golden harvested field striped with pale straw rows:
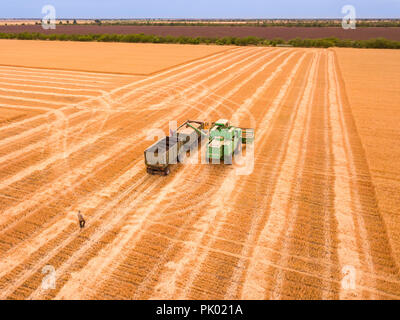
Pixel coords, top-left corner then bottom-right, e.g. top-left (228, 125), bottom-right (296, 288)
top-left (0, 42), bottom-right (400, 299)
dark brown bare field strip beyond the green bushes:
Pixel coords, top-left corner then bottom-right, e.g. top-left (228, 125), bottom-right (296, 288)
top-left (0, 25), bottom-right (400, 41)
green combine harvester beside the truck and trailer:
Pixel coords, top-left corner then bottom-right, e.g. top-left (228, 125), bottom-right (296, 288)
top-left (206, 119), bottom-right (254, 164)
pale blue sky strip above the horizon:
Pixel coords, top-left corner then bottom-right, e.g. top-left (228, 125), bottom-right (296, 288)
top-left (0, 0), bottom-right (400, 18)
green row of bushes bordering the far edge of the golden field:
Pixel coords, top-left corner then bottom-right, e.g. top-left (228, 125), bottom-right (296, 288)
top-left (0, 32), bottom-right (400, 49)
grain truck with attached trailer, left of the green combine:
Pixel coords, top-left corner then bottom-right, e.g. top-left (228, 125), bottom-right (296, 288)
top-left (144, 120), bottom-right (207, 176)
